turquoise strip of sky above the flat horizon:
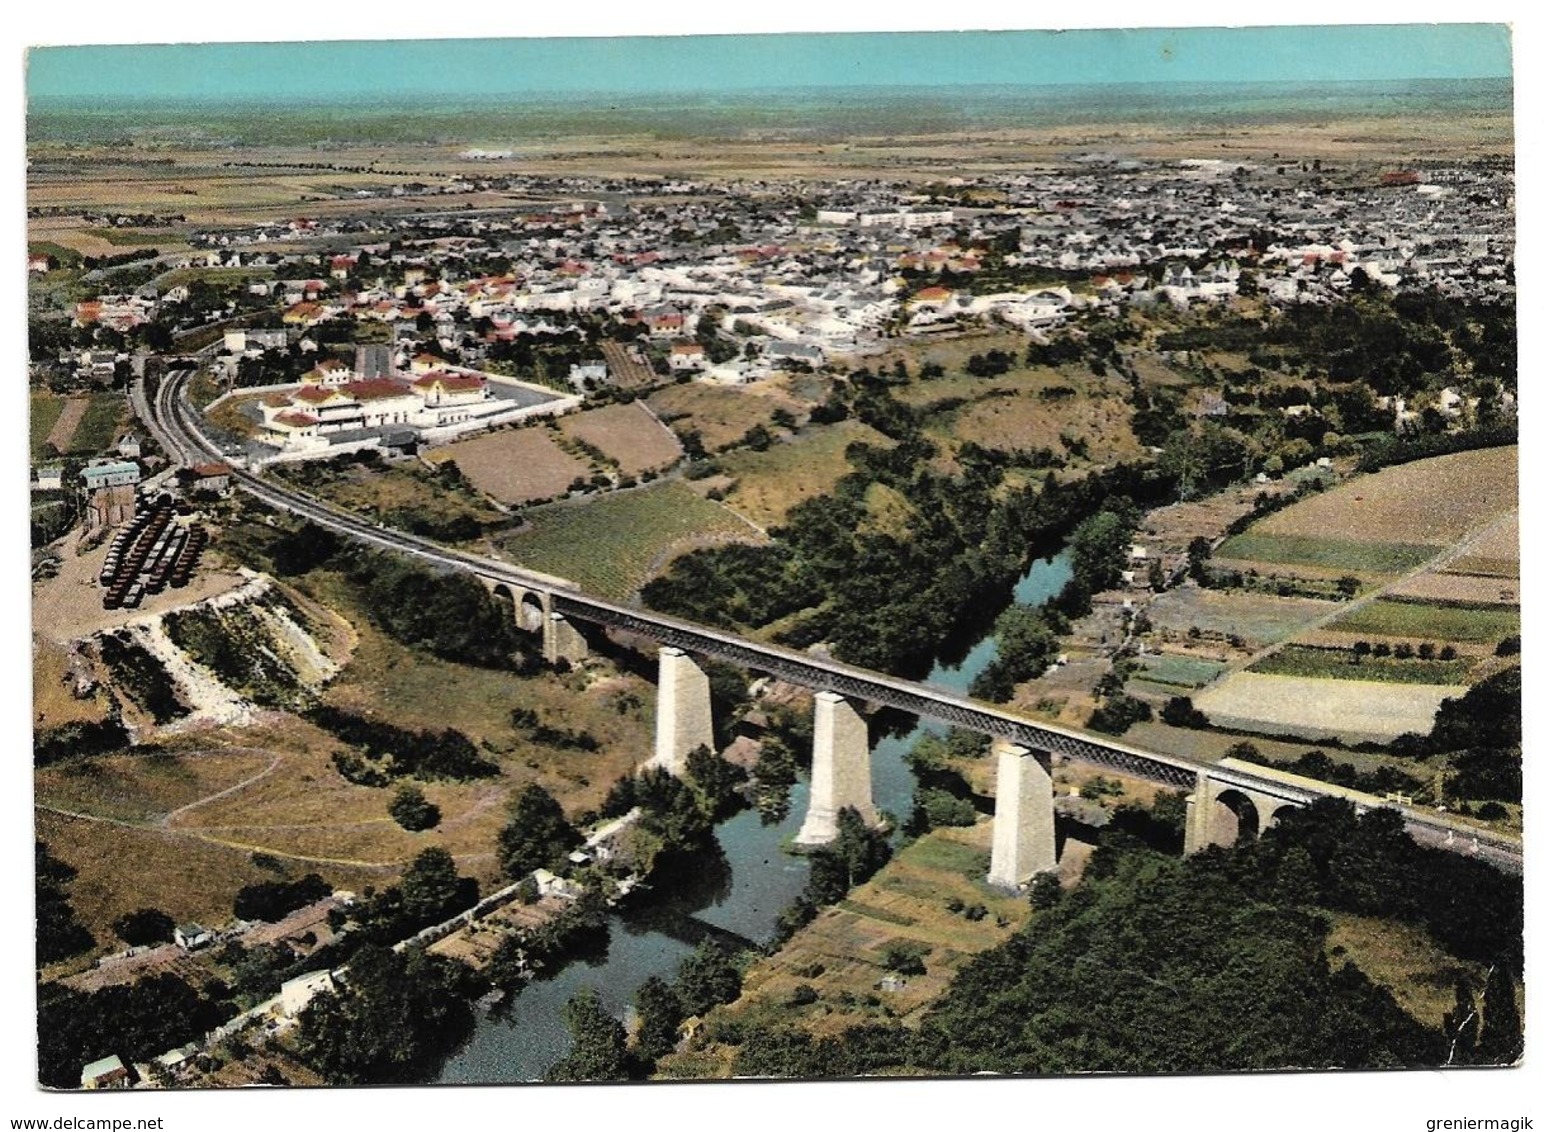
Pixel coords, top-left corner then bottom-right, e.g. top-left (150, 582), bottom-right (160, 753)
top-left (28, 23), bottom-right (1512, 100)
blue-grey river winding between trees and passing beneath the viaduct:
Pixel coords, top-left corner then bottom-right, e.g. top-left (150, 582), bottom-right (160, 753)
top-left (437, 551), bottom-right (1072, 1084)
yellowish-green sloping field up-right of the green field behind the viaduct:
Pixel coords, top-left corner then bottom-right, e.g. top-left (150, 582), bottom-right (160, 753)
top-left (720, 420), bottom-right (896, 527)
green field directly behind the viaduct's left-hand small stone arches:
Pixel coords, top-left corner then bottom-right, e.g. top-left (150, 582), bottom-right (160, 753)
top-left (500, 483), bottom-right (757, 599)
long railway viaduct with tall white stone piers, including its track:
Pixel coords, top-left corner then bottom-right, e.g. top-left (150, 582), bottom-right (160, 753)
top-left (150, 370), bottom-right (1521, 890)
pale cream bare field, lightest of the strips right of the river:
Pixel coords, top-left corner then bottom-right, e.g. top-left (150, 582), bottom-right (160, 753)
top-left (1195, 672), bottom-right (1464, 743)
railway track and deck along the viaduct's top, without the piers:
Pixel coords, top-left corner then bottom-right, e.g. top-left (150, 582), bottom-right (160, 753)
top-left (136, 366), bottom-right (1521, 866)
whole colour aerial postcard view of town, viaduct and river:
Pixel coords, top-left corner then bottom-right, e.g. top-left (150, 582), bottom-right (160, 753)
top-left (17, 25), bottom-right (1524, 1115)
